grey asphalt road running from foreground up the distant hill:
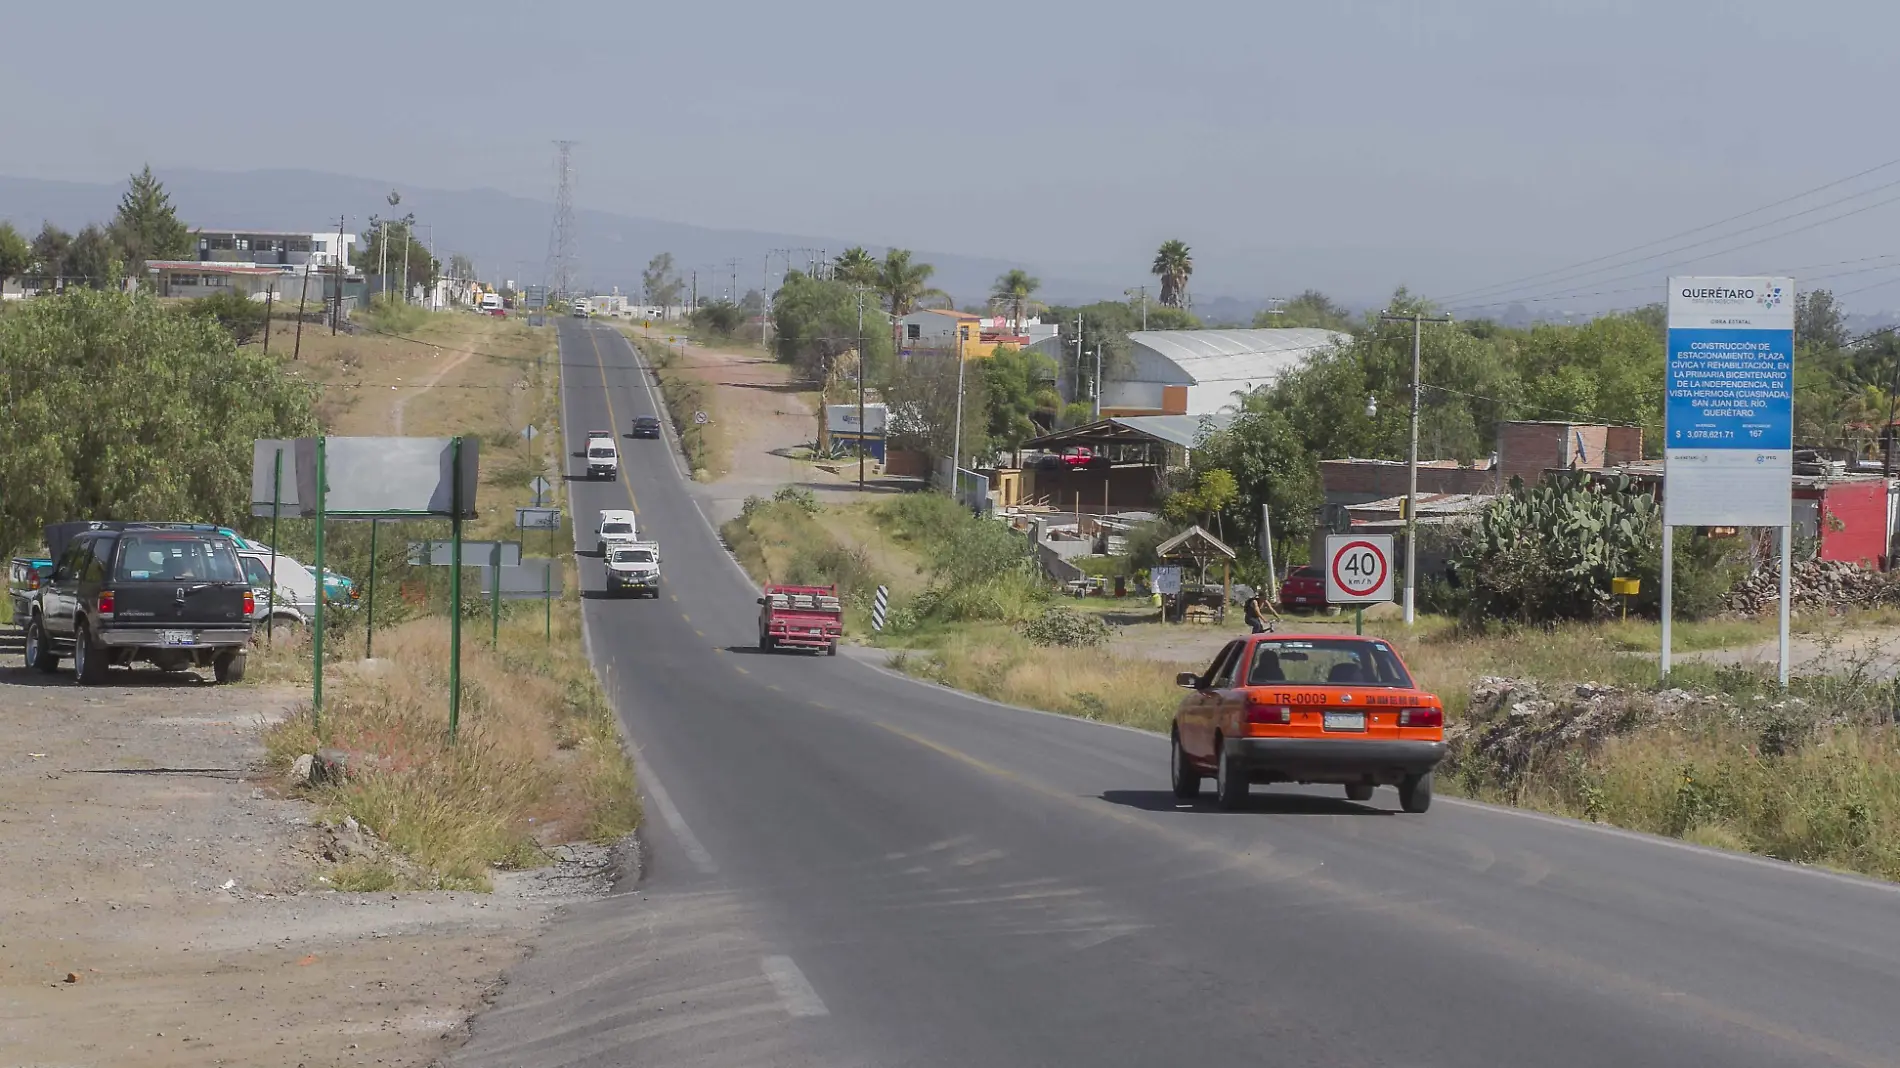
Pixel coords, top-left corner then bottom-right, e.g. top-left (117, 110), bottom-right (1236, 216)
top-left (454, 321), bottom-right (1900, 1068)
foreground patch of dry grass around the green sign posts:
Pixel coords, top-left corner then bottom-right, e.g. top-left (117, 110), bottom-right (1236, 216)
top-left (268, 599), bottom-right (640, 887)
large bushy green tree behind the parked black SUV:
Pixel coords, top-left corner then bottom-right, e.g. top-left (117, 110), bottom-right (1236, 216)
top-left (0, 289), bottom-right (315, 555)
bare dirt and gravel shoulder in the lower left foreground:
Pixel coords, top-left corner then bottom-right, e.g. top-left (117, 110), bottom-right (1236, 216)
top-left (0, 642), bottom-right (604, 1068)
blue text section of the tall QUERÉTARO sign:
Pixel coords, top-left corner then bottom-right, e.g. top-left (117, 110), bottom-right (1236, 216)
top-left (1666, 329), bottom-right (1794, 450)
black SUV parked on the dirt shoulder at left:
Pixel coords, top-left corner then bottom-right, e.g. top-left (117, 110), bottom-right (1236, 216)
top-left (27, 523), bottom-right (257, 686)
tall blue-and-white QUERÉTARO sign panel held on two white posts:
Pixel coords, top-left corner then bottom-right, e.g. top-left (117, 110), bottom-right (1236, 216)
top-left (1663, 277), bottom-right (1794, 526)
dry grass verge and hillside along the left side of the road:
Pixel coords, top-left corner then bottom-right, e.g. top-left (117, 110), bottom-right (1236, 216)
top-left (251, 305), bottom-right (640, 889)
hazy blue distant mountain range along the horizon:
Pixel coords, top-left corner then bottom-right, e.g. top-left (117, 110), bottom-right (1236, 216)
top-left (0, 169), bottom-right (1124, 305)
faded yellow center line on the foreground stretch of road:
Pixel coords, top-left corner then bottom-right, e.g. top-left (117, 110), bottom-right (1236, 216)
top-left (870, 714), bottom-right (1894, 1068)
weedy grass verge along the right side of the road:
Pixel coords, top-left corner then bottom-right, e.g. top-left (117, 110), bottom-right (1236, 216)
top-left (722, 488), bottom-right (1900, 878)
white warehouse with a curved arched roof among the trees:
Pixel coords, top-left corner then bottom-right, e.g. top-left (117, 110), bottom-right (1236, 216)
top-left (1102, 329), bottom-right (1351, 418)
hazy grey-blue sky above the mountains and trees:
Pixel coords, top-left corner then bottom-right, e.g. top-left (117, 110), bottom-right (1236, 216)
top-left (0, 0), bottom-right (1900, 308)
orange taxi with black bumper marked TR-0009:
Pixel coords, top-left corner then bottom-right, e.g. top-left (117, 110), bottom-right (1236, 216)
top-left (1172, 635), bottom-right (1444, 811)
